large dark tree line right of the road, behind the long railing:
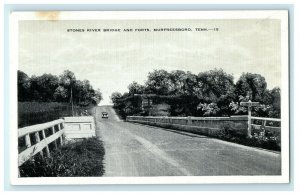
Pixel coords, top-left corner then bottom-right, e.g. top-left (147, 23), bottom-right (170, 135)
top-left (111, 69), bottom-right (280, 118)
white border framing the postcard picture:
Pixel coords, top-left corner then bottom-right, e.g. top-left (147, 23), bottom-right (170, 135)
top-left (9, 10), bottom-right (289, 185)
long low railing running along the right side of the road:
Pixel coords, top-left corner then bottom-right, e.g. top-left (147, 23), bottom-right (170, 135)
top-left (126, 115), bottom-right (281, 137)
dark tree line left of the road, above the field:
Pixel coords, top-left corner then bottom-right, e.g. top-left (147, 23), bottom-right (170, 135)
top-left (17, 70), bottom-right (102, 106)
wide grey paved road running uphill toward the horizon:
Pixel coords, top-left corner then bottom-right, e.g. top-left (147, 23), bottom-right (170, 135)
top-left (95, 106), bottom-right (281, 176)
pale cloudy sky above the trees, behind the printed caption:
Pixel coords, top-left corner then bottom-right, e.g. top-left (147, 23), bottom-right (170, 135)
top-left (18, 19), bottom-right (281, 105)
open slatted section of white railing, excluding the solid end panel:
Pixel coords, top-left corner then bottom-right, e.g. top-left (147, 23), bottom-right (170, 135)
top-left (18, 119), bottom-right (65, 166)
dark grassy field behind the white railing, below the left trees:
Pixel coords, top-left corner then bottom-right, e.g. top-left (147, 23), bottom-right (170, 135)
top-left (18, 102), bottom-right (91, 128)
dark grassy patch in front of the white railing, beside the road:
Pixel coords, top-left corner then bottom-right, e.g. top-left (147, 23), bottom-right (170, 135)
top-left (19, 137), bottom-right (105, 177)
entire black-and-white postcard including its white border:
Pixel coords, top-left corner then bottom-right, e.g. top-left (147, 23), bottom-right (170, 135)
top-left (10, 10), bottom-right (289, 185)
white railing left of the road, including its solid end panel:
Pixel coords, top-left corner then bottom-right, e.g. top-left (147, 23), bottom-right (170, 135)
top-left (18, 116), bottom-right (96, 167)
